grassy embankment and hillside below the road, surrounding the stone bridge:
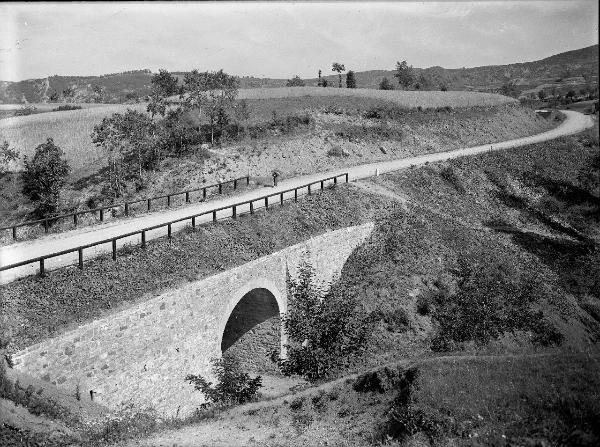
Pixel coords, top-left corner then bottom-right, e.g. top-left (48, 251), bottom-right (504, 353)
top-left (0, 124), bottom-right (600, 446)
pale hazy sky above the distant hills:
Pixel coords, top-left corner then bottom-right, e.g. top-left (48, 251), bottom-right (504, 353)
top-left (0, 0), bottom-right (598, 81)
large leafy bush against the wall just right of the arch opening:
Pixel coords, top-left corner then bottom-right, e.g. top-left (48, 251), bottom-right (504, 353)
top-left (279, 259), bottom-right (372, 382)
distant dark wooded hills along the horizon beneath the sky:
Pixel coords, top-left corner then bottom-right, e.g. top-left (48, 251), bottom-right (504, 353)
top-left (0, 45), bottom-right (598, 103)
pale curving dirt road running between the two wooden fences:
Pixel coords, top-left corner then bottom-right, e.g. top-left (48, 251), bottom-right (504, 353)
top-left (0, 111), bottom-right (594, 284)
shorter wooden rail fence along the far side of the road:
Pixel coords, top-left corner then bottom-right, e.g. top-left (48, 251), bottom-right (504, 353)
top-left (0, 175), bottom-right (250, 240)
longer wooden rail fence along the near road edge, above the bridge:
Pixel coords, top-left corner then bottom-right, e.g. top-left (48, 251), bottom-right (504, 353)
top-left (0, 173), bottom-right (349, 276)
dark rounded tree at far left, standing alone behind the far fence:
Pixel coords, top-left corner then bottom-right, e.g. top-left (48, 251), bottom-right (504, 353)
top-left (21, 138), bottom-right (70, 218)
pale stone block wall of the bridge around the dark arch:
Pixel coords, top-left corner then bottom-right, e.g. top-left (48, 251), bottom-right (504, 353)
top-left (14, 223), bottom-right (373, 415)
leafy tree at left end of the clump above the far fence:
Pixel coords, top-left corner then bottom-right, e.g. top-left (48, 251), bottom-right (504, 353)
top-left (91, 109), bottom-right (161, 198)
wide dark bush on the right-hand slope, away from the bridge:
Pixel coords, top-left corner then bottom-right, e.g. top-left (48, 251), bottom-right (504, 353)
top-left (432, 253), bottom-right (562, 351)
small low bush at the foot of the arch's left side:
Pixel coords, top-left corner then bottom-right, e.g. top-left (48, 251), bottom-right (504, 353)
top-left (185, 355), bottom-right (262, 405)
